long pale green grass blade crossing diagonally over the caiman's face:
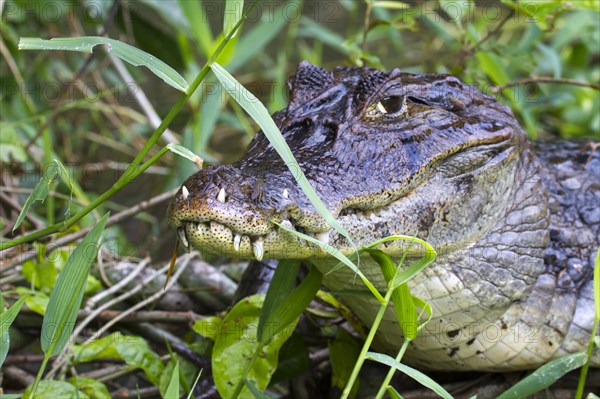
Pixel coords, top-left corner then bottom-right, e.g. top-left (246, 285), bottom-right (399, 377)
top-left (212, 63), bottom-right (354, 250)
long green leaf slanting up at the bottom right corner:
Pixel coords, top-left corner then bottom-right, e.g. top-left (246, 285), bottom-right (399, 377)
top-left (498, 352), bottom-right (587, 399)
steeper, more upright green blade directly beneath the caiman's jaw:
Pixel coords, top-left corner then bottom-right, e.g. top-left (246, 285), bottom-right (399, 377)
top-left (256, 260), bottom-right (300, 342)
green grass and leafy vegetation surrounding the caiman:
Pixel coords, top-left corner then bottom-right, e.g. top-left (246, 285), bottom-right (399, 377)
top-left (0, 0), bottom-right (600, 398)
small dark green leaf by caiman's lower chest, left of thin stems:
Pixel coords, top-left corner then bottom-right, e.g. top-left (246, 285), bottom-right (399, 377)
top-left (327, 327), bottom-right (360, 397)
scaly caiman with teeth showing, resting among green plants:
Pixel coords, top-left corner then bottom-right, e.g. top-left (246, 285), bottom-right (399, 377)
top-left (168, 62), bottom-right (600, 371)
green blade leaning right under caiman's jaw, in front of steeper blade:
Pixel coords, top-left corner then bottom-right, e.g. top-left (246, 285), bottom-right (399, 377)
top-left (259, 267), bottom-right (323, 344)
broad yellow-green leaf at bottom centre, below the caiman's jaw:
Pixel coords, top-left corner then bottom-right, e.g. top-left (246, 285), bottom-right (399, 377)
top-left (212, 295), bottom-right (295, 398)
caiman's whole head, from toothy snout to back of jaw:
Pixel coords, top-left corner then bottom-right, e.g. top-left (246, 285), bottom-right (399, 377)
top-left (168, 62), bottom-right (527, 259)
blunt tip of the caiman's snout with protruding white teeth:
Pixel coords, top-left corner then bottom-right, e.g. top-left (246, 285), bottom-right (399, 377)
top-left (168, 165), bottom-right (322, 260)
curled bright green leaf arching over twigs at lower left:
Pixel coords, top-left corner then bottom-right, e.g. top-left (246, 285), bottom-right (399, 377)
top-left (72, 333), bottom-right (164, 384)
